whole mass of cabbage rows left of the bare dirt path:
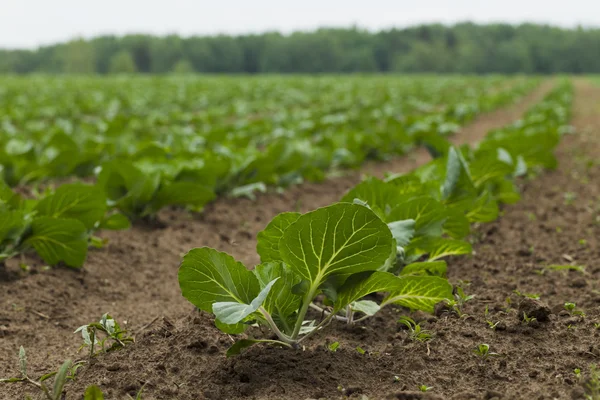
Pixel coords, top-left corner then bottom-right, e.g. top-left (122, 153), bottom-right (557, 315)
top-left (0, 77), bottom-right (539, 267)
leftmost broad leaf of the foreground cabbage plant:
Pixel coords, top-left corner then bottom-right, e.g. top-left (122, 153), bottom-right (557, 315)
top-left (178, 247), bottom-right (260, 312)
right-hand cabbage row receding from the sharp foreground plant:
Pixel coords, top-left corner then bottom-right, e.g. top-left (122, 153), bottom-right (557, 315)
top-left (179, 82), bottom-right (572, 355)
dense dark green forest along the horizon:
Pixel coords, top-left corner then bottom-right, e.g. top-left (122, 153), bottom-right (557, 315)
top-left (0, 23), bottom-right (600, 74)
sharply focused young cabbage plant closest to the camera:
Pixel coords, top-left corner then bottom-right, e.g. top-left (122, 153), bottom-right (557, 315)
top-left (179, 203), bottom-right (451, 355)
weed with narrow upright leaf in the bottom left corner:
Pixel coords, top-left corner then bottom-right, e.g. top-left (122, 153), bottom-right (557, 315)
top-left (0, 346), bottom-right (82, 400)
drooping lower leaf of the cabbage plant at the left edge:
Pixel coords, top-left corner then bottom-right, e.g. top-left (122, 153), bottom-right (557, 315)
top-left (25, 217), bottom-right (88, 267)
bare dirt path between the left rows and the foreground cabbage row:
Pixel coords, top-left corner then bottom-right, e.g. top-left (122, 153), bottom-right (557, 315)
top-left (0, 81), bottom-right (552, 399)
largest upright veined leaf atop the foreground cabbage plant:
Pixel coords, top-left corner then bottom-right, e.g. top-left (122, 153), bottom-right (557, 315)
top-left (279, 203), bottom-right (393, 288)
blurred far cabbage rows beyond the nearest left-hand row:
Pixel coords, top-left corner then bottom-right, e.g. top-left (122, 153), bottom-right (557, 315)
top-left (0, 76), bottom-right (528, 187)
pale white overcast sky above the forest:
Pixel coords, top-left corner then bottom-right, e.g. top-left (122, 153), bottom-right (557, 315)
top-left (0, 0), bottom-right (600, 48)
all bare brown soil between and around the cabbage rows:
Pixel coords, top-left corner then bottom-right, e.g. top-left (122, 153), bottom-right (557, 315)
top-left (0, 83), bottom-right (600, 400)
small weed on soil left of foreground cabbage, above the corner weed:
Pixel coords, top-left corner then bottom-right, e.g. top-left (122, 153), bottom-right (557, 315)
top-left (75, 314), bottom-right (134, 357)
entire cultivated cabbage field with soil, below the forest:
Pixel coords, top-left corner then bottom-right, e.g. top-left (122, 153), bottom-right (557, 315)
top-left (0, 76), bottom-right (600, 400)
